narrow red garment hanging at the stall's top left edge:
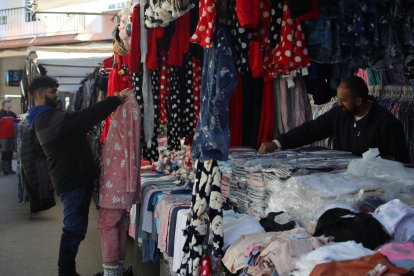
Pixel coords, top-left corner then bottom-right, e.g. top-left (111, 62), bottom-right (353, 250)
top-left (127, 4), bottom-right (141, 73)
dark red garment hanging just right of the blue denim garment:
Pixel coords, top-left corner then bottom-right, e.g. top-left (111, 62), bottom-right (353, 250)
top-left (229, 73), bottom-right (243, 147)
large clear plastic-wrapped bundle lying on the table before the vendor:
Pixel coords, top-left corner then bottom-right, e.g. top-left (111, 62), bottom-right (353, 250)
top-left (266, 173), bottom-right (384, 232)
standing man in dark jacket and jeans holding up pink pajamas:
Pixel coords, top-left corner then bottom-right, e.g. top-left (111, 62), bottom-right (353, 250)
top-left (27, 76), bottom-right (129, 276)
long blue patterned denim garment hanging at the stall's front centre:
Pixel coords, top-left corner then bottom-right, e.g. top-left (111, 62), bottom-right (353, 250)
top-left (192, 26), bottom-right (237, 161)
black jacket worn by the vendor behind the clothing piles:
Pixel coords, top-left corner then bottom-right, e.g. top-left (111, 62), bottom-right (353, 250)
top-left (277, 101), bottom-right (410, 163)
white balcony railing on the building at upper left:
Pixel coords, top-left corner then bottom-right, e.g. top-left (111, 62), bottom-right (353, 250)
top-left (0, 7), bottom-right (86, 40)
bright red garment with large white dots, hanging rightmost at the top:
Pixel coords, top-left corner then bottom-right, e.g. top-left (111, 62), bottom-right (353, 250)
top-left (264, 0), bottom-right (310, 78)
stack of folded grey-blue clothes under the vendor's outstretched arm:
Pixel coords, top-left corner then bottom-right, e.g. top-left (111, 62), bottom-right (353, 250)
top-left (229, 147), bottom-right (355, 217)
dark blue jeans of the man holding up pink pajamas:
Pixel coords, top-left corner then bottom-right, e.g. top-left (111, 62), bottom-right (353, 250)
top-left (58, 185), bottom-right (92, 276)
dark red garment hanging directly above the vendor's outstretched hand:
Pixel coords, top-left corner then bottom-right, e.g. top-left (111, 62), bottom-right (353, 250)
top-left (257, 80), bottom-right (275, 146)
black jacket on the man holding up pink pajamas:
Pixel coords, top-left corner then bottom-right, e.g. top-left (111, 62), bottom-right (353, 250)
top-left (35, 97), bottom-right (121, 194)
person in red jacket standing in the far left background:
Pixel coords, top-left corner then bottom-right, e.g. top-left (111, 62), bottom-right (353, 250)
top-left (0, 100), bottom-right (17, 175)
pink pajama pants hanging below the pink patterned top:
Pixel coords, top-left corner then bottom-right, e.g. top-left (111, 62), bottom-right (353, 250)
top-left (97, 207), bottom-right (128, 263)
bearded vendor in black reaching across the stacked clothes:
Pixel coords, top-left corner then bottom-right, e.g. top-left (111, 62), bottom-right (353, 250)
top-left (259, 76), bottom-right (410, 163)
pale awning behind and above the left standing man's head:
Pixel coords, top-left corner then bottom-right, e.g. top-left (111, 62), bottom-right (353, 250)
top-left (27, 42), bottom-right (113, 93)
